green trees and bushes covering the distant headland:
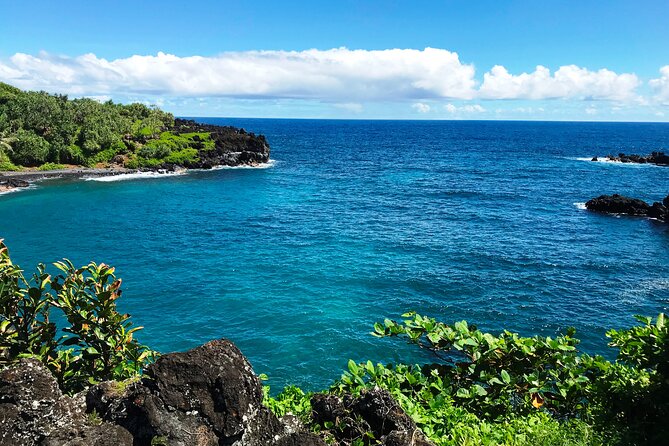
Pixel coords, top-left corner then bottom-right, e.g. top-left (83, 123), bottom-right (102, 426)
top-left (0, 82), bottom-right (214, 170)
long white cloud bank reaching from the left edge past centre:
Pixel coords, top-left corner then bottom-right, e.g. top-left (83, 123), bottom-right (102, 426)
top-left (0, 48), bottom-right (476, 103)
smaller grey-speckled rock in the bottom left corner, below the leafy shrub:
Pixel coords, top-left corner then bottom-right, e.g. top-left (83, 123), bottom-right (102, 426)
top-left (0, 359), bottom-right (133, 446)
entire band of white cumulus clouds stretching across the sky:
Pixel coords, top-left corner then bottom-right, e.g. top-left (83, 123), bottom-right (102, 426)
top-left (0, 48), bottom-right (648, 106)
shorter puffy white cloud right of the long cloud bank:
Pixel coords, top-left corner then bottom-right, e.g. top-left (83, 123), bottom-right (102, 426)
top-left (479, 65), bottom-right (639, 100)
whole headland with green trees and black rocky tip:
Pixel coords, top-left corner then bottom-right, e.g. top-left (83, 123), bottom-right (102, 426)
top-left (0, 82), bottom-right (269, 171)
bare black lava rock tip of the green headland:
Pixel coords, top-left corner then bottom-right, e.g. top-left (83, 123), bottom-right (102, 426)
top-left (171, 119), bottom-right (270, 169)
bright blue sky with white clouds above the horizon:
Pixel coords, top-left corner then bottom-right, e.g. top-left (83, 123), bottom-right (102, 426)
top-left (0, 0), bottom-right (669, 122)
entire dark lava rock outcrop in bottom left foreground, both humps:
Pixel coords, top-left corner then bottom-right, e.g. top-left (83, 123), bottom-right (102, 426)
top-left (0, 340), bottom-right (325, 446)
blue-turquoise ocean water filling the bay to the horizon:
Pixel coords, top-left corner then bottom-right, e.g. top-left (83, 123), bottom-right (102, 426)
top-left (0, 119), bottom-right (669, 389)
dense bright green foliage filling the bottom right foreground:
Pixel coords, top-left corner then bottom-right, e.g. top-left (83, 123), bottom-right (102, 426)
top-left (266, 313), bottom-right (669, 445)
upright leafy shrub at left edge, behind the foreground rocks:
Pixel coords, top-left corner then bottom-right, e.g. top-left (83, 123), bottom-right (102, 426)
top-left (0, 240), bottom-right (155, 392)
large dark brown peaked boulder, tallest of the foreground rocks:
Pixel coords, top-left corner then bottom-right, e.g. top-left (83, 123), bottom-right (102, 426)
top-left (86, 340), bottom-right (324, 446)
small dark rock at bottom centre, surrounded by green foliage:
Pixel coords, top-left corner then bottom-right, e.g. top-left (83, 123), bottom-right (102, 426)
top-left (311, 389), bottom-right (432, 446)
